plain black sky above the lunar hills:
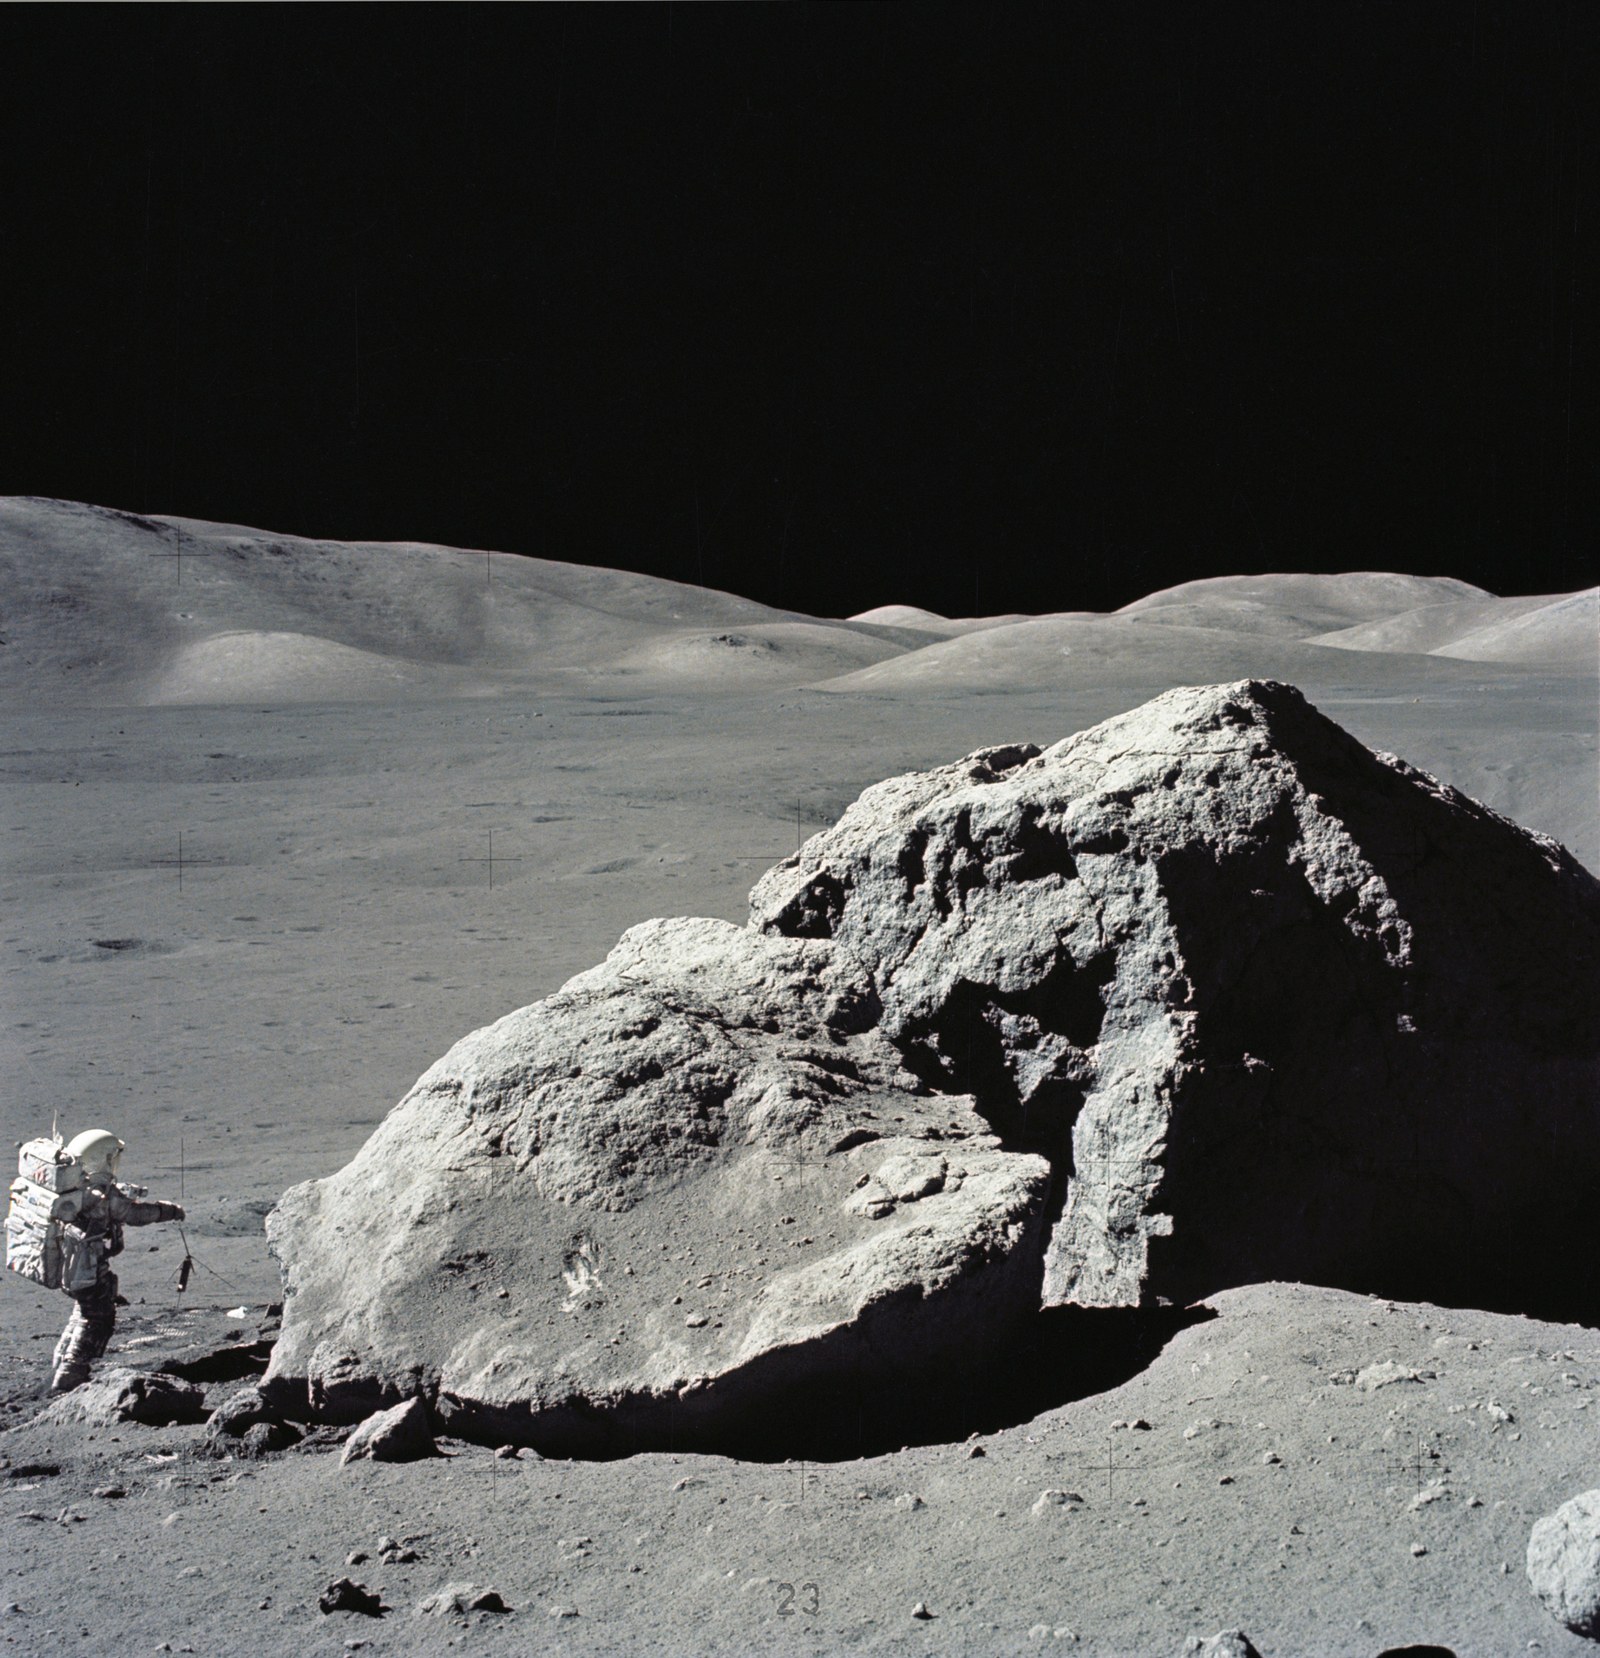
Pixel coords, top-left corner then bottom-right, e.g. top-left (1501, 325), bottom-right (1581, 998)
top-left (0, 0), bottom-right (1600, 615)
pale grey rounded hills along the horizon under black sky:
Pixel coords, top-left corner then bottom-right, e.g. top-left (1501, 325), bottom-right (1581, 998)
top-left (0, 496), bottom-right (1600, 706)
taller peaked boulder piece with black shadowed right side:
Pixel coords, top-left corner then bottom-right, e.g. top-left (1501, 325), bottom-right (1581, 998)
top-left (751, 681), bottom-right (1600, 1321)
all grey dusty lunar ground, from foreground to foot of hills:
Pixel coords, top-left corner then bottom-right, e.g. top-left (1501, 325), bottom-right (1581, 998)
top-left (0, 510), bottom-right (1600, 1658)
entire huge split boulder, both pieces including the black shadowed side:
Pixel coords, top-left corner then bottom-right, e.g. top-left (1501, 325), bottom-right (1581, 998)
top-left (264, 681), bottom-right (1600, 1454)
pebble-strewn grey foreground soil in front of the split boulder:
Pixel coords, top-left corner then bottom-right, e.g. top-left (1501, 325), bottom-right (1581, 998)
top-left (0, 1285), bottom-right (1600, 1658)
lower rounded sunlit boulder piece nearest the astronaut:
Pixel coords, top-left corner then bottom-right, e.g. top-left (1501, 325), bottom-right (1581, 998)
top-left (264, 920), bottom-right (1051, 1454)
